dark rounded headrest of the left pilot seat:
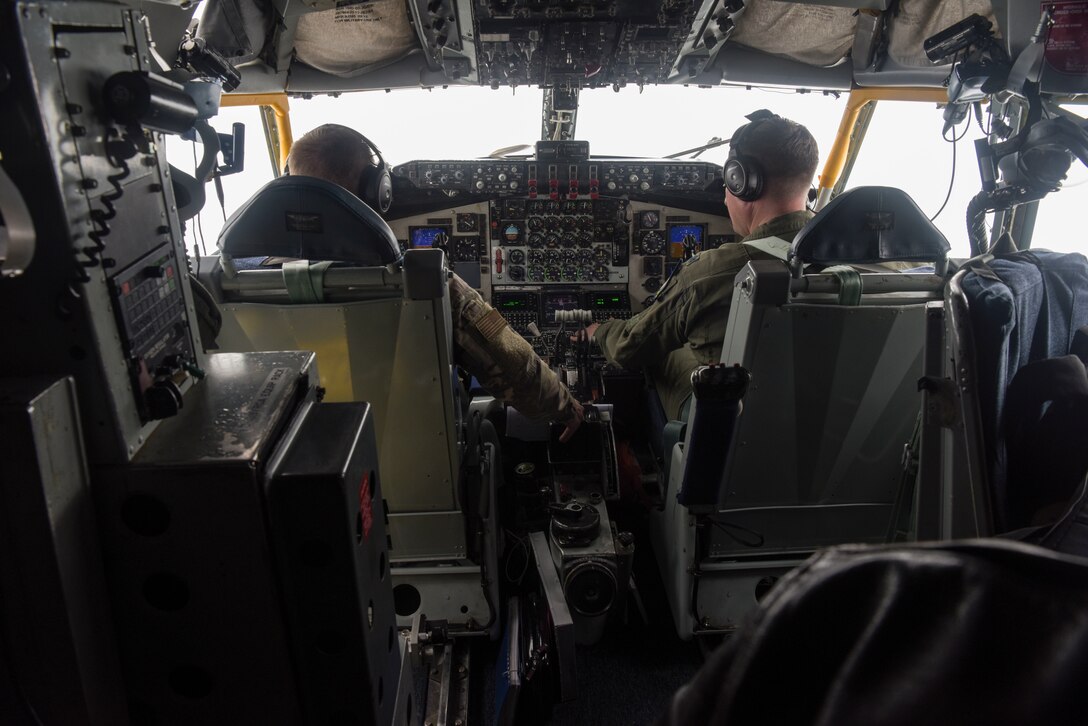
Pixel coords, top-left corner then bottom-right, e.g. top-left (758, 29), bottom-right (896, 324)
top-left (219, 175), bottom-right (400, 267)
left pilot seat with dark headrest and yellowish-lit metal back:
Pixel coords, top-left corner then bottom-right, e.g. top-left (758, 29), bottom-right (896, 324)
top-left (199, 175), bottom-right (498, 632)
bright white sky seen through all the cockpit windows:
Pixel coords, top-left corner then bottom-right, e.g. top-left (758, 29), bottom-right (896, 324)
top-left (168, 86), bottom-right (1088, 261)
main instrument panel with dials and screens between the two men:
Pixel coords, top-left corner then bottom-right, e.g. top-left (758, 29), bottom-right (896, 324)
top-left (390, 158), bottom-right (737, 346)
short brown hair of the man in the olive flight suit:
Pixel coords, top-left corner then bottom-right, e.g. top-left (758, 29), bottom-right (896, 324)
top-left (733, 116), bottom-right (819, 196)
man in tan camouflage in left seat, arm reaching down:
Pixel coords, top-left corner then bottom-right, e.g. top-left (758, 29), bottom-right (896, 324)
top-left (287, 124), bottom-right (583, 441)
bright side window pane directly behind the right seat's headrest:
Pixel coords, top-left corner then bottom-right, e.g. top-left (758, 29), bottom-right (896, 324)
top-left (846, 101), bottom-right (987, 257)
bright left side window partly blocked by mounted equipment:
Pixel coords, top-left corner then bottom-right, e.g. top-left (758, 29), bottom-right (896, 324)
top-left (166, 106), bottom-right (274, 255)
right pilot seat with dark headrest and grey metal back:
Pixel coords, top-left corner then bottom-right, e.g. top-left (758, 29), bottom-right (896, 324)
top-left (652, 187), bottom-right (949, 638)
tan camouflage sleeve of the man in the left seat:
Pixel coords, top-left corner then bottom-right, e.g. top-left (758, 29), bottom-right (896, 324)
top-left (449, 275), bottom-right (576, 423)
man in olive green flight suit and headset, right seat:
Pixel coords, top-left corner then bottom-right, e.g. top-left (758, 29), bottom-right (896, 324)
top-left (586, 111), bottom-right (819, 419)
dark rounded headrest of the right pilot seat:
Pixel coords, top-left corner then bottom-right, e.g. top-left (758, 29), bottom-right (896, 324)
top-left (790, 186), bottom-right (949, 264)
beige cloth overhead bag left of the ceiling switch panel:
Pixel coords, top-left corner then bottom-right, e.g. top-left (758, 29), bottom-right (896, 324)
top-left (295, 0), bottom-right (420, 77)
